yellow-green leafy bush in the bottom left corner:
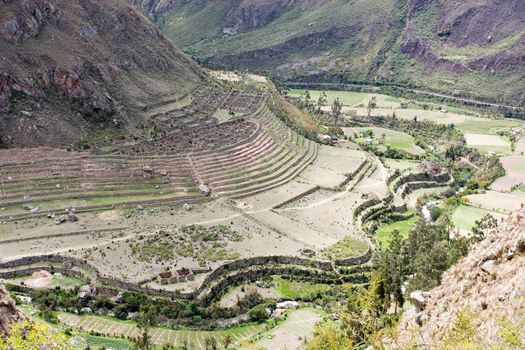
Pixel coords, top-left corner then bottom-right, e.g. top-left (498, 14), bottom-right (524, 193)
top-left (0, 320), bottom-right (73, 350)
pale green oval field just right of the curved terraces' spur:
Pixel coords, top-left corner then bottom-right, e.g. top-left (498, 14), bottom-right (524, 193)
top-left (352, 127), bottom-right (424, 155)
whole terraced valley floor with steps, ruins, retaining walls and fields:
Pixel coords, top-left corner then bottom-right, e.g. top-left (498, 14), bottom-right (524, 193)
top-left (5, 72), bottom-right (525, 349)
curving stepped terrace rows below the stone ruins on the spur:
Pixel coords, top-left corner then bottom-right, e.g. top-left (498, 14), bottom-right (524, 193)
top-left (0, 96), bottom-right (318, 217)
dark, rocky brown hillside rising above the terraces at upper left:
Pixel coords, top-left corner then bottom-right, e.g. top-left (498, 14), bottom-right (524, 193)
top-left (0, 0), bottom-right (206, 147)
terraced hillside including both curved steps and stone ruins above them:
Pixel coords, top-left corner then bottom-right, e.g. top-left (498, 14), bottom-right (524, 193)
top-left (0, 90), bottom-right (318, 220)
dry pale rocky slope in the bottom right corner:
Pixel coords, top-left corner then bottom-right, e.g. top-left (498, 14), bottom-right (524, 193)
top-left (396, 207), bottom-right (525, 349)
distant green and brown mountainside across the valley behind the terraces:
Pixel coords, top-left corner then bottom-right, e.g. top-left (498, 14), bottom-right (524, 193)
top-left (129, 0), bottom-right (525, 105)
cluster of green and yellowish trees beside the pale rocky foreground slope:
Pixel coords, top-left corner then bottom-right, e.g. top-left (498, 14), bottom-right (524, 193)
top-left (308, 215), bottom-right (476, 350)
